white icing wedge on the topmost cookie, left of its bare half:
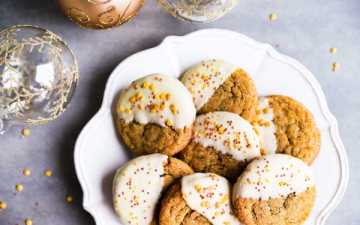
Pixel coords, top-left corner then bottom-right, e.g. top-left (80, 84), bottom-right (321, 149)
top-left (181, 59), bottom-right (236, 110)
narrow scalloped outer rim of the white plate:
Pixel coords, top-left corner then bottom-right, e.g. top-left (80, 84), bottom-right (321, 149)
top-left (74, 28), bottom-right (349, 225)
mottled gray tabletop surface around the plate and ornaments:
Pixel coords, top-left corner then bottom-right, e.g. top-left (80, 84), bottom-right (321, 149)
top-left (0, 0), bottom-right (360, 225)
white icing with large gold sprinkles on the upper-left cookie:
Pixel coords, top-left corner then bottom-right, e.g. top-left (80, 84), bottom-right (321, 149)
top-left (117, 74), bottom-right (196, 129)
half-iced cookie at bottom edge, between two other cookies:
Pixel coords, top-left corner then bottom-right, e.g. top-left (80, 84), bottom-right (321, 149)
top-left (159, 173), bottom-right (240, 225)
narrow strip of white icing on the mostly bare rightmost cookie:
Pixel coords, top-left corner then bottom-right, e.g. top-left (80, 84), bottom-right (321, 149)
top-left (256, 97), bottom-right (277, 154)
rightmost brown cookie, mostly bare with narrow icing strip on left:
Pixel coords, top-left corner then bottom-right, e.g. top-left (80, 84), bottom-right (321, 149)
top-left (255, 95), bottom-right (320, 165)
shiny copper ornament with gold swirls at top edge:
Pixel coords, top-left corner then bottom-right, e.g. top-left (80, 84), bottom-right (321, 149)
top-left (58, 0), bottom-right (144, 29)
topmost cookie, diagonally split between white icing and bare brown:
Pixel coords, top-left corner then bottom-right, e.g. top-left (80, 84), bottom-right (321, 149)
top-left (181, 60), bottom-right (257, 121)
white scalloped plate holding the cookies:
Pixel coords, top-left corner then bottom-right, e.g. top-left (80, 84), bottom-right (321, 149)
top-left (75, 29), bottom-right (349, 225)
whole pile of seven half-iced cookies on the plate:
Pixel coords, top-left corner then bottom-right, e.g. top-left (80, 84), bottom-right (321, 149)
top-left (113, 60), bottom-right (320, 225)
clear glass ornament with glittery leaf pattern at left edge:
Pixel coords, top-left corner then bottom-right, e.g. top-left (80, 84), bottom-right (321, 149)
top-left (0, 25), bottom-right (79, 133)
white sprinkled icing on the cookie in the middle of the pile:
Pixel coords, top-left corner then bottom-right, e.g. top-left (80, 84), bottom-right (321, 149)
top-left (193, 112), bottom-right (261, 161)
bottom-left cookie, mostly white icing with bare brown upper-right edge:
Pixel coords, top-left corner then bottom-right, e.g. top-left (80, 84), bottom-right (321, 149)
top-left (113, 153), bottom-right (193, 225)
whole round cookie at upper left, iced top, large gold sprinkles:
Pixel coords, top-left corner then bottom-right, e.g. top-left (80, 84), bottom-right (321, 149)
top-left (115, 74), bottom-right (196, 156)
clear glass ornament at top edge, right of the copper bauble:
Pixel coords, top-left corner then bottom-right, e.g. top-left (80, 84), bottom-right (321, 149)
top-left (158, 0), bottom-right (238, 23)
